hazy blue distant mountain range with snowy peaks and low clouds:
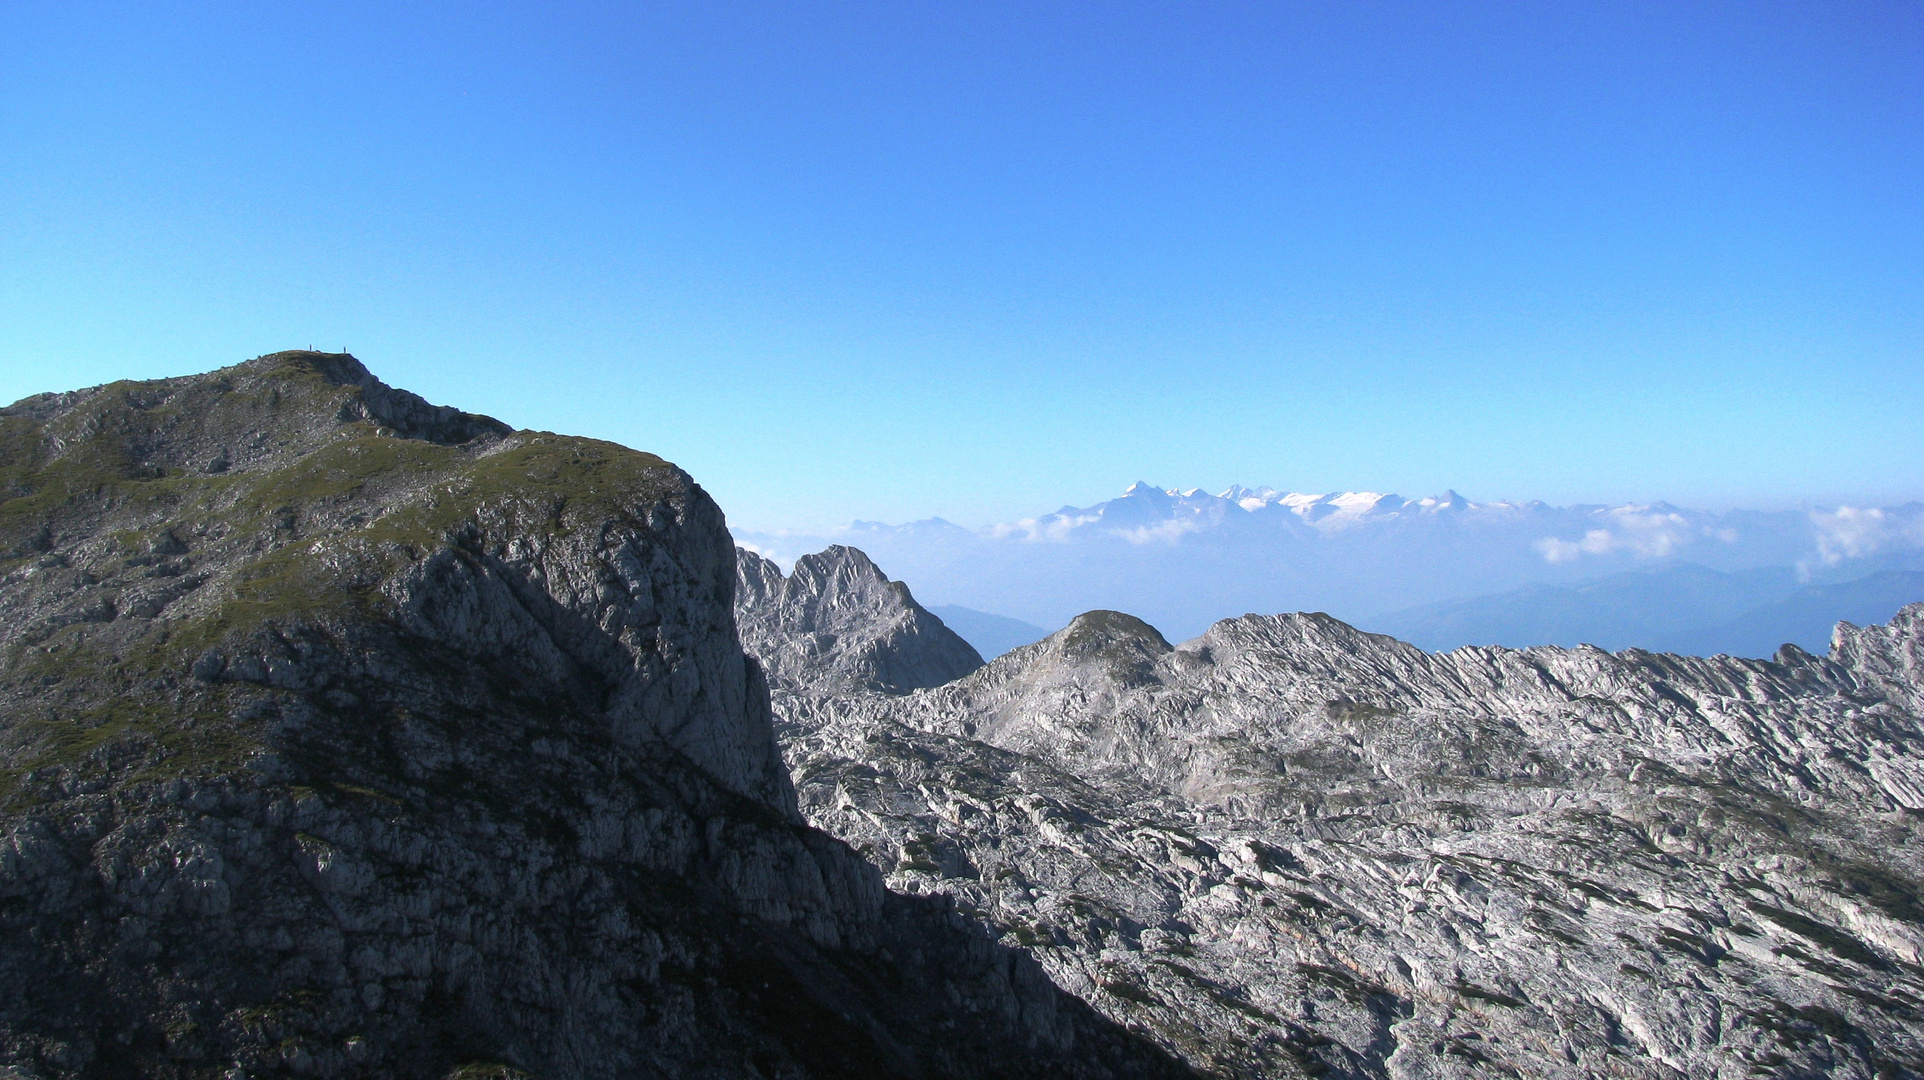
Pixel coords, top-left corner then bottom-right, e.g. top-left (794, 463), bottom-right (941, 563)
top-left (735, 483), bottom-right (1924, 656)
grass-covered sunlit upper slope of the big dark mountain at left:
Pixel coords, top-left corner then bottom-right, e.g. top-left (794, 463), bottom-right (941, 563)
top-left (0, 365), bottom-right (687, 801)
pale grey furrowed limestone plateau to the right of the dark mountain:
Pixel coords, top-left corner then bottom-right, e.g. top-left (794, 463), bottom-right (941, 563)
top-left (737, 549), bottom-right (1924, 1080)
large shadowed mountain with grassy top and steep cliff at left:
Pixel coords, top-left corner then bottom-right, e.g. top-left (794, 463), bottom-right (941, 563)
top-left (0, 352), bottom-right (1179, 1080)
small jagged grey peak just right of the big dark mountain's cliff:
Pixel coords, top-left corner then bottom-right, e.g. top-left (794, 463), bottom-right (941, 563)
top-left (735, 547), bottom-right (981, 693)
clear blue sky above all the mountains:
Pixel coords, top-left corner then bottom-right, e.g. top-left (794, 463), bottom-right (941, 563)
top-left (0, 0), bottom-right (1924, 527)
